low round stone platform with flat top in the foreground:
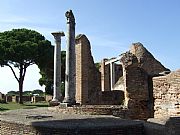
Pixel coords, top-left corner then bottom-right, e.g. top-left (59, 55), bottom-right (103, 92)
top-left (0, 106), bottom-right (144, 135)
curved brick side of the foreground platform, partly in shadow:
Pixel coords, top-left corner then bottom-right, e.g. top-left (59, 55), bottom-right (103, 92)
top-left (0, 121), bottom-right (144, 135)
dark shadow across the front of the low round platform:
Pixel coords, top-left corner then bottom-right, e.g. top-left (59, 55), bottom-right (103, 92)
top-left (32, 118), bottom-right (144, 135)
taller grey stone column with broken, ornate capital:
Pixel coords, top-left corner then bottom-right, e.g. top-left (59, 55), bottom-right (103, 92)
top-left (64, 10), bottom-right (76, 105)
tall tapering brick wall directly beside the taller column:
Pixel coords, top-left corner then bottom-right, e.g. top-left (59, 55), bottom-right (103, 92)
top-left (76, 35), bottom-right (101, 104)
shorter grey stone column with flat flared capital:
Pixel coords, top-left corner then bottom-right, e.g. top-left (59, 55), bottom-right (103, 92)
top-left (51, 32), bottom-right (64, 102)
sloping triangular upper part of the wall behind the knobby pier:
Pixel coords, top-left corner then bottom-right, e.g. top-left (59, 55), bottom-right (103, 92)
top-left (130, 43), bottom-right (169, 76)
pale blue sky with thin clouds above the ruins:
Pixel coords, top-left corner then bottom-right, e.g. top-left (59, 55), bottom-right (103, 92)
top-left (0, 0), bottom-right (180, 92)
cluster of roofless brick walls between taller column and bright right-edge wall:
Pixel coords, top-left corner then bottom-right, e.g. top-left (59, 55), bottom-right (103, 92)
top-left (73, 35), bottom-right (174, 119)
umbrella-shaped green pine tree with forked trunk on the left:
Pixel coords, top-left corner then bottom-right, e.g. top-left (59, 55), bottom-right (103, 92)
top-left (0, 28), bottom-right (53, 104)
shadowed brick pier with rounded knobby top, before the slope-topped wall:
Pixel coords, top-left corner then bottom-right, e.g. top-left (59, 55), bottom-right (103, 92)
top-left (121, 52), bottom-right (149, 119)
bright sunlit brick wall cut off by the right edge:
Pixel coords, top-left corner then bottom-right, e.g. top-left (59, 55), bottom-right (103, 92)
top-left (153, 70), bottom-right (180, 118)
